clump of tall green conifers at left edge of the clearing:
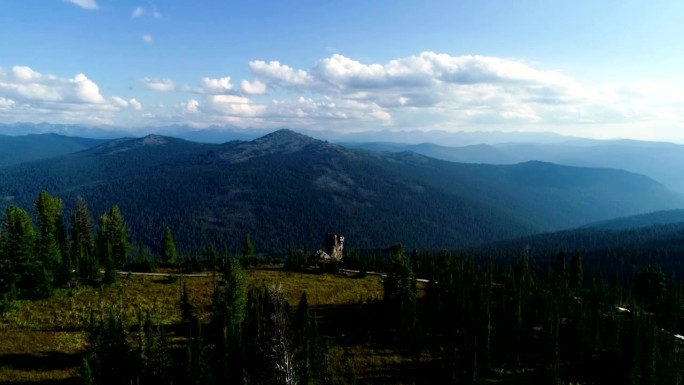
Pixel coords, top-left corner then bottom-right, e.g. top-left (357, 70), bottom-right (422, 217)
top-left (0, 191), bottom-right (139, 301)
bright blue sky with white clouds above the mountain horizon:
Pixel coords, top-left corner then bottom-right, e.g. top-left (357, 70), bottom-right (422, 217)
top-left (0, 0), bottom-right (684, 143)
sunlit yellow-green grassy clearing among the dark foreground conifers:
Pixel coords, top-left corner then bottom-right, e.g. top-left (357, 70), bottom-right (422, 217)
top-left (0, 269), bottom-right (382, 384)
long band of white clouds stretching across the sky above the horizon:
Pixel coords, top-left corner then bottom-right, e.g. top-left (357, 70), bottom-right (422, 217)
top-left (0, 52), bottom-right (684, 140)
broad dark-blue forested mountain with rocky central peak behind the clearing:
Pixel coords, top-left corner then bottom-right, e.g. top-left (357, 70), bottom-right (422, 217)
top-left (0, 130), bottom-right (684, 252)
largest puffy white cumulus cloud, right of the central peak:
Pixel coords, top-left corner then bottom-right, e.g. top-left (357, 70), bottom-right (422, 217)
top-left (250, 52), bottom-right (616, 125)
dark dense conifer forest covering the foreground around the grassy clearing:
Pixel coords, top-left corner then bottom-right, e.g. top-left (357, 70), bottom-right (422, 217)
top-left (0, 191), bottom-right (684, 384)
